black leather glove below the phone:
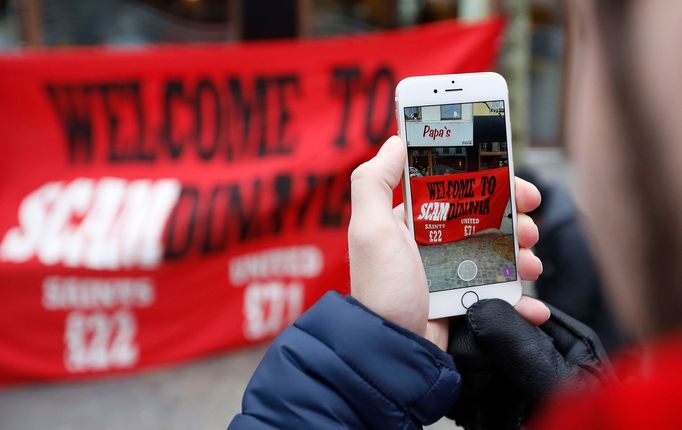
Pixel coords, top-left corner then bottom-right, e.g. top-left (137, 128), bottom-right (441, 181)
top-left (448, 299), bottom-right (612, 429)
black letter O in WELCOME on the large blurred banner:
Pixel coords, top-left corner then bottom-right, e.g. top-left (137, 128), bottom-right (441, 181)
top-left (194, 79), bottom-right (222, 160)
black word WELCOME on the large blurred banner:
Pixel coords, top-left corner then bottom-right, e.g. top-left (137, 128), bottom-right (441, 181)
top-left (44, 73), bottom-right (302, 163)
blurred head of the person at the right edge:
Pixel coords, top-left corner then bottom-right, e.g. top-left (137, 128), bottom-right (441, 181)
top-left (565, 0), bottom-right (682, 336)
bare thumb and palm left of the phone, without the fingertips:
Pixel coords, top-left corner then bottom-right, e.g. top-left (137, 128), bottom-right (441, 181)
top-left (348, 136), bottom-right (429, 336)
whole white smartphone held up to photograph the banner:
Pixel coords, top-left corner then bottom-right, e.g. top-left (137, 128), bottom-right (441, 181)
top-left (396, 73), bottom-right (521, 318)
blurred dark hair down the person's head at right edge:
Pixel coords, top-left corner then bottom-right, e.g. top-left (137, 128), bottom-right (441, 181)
top-left (595, 0), bottom-right (682, 334)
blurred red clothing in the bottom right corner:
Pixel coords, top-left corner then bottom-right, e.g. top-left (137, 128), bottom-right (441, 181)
top-left (532, 336), bottom-right (682, 430)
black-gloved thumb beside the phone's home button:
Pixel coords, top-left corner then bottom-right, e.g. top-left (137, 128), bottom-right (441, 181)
top-left (467, 299), bottom-right (577, 400)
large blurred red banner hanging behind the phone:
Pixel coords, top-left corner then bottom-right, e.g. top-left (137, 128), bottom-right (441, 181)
top-left (0, 20), bottom-right (503, 383)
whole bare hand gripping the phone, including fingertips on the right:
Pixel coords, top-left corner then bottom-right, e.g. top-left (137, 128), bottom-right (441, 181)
top-left (348, 136), bottom-right (549, 340)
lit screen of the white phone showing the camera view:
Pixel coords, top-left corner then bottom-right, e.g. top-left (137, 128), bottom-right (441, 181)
top-left (404, 100), bottom-right (517, 292)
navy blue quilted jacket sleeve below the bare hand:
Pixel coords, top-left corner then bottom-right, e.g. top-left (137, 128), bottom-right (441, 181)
top-left (229, 292), bottom-right (461, 430)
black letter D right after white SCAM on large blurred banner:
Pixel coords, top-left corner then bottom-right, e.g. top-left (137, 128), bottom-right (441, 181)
top-left (164, 187), bottom-right (199, 260)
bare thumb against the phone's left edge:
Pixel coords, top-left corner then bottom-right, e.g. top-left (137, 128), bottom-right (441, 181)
top-left (350, 136), bottom-right (407, 223)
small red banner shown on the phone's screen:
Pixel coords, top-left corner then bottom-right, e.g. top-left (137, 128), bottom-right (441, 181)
top-left (410, 167), bottom-right (510, 245)
